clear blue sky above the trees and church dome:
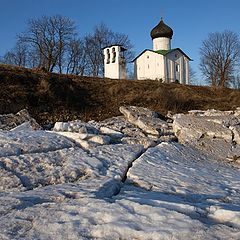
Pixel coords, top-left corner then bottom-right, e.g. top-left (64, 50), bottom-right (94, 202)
top-left (0, 0), bottom-right (240, 82)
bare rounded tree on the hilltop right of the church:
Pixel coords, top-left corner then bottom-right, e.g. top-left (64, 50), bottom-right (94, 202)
top-left (200, 30), bottom-right (240, 87)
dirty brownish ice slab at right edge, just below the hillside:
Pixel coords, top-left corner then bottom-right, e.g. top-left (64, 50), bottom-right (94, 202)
top-left (173, 110), bottom-right (240, 164)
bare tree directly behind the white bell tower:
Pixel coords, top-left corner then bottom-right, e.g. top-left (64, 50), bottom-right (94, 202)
top-left (85, 24), bottom-right (133, 76)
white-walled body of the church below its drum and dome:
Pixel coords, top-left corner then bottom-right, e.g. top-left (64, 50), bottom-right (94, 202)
top-left (134, 49), bottom-right (189, 84)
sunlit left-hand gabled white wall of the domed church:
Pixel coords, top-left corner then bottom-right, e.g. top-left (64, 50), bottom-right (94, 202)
top-left (135, 51), bottom-right (165, 80)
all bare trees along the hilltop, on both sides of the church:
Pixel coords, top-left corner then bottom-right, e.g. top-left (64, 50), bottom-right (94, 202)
top-left (0, 15), bottom-right (240, 89)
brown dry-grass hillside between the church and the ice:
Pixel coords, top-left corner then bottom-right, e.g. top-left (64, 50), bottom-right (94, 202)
top-left (0, 65), bottom-right (240, 124)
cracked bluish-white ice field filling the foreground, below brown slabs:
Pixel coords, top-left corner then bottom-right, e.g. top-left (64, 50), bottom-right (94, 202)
top-left (0, 109), bottom-right (240, 240)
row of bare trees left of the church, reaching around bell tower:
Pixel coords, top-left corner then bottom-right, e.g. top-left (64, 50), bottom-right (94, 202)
top-left (1, 15), bottom-right (133, 76)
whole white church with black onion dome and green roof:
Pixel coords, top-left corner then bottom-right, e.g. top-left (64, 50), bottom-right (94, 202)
top-left (133, 18), bottom-right (191, 84)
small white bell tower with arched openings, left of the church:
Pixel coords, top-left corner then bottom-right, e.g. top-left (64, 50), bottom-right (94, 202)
top-left (104, 45), bottom-right (126, 79)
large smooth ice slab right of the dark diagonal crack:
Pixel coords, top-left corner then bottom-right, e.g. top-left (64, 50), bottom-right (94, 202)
top-left (128, 143), bottom-right (240, 227)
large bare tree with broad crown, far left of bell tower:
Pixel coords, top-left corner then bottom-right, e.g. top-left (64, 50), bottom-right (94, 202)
top-left (18, 15), bottom-right (75, 73)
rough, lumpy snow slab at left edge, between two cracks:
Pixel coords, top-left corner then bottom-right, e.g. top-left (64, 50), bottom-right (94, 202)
top-left (0, 148), bottom-right (102, 189)
